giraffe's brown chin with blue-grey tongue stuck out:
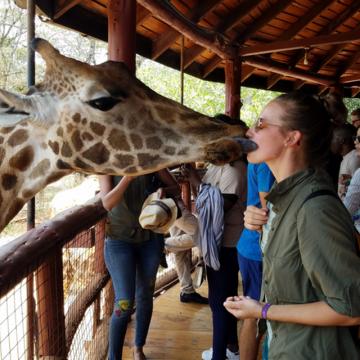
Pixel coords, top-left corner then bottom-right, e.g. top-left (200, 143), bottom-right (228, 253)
top-left (205, 137), bottom-right (257, 165)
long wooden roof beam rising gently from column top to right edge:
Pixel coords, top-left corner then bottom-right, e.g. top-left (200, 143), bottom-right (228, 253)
top-left (239, 29), bottom-right (360, 56)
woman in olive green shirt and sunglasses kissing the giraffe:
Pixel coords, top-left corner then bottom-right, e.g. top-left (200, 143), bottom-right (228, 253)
top-left (224, 92), bottom-right (360, 360)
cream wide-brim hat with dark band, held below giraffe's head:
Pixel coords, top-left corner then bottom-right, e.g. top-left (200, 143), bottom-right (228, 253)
top-left (139, 192), bottom-right (178, 234)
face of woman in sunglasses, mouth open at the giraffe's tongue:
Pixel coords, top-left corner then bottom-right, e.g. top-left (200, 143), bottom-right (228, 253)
top-left (246, 101), bottom-right (286, 164)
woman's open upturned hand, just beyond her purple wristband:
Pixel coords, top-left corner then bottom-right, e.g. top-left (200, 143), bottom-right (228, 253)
top-left (224, 296), bottom-right (262, 319)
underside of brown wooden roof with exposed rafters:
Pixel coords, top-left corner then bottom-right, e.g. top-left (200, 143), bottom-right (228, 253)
top-left (16, 0), bottom-right (360, 97)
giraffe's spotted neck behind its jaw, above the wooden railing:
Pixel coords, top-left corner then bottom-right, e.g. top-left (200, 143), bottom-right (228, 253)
top-left (0, 123), bottom-right (71, 232)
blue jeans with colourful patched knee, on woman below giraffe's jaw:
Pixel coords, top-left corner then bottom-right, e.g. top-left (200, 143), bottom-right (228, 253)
top-left (104, 233), bottom-right (164, 360)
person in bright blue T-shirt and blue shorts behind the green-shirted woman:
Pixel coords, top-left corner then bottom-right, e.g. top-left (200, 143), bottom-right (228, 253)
top-left (237, 163), bottom-right (274, 360)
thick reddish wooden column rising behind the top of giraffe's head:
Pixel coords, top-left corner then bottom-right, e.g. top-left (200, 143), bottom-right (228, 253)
top-left (108, 0), bottom-right (136, 73)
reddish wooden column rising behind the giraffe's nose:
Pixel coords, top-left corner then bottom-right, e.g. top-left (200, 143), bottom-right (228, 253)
top-left (225, 58), bottom-right (241, 118)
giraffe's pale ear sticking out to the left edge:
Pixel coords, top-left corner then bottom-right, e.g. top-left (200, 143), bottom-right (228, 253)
top-left (0, 89), bottom-right (56, 127)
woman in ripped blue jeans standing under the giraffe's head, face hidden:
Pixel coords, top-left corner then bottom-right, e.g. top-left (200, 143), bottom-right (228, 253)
top-left (99, 170), bottom-right (179, 360)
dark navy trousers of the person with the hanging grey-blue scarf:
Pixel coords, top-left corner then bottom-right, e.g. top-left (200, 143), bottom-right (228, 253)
top-left (206, 247), bottom-right (239, 360)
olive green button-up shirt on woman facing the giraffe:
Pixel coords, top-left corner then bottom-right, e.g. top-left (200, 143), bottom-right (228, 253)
top-left (263, 169), bottom-right (360, 360)
